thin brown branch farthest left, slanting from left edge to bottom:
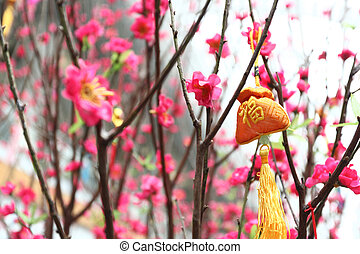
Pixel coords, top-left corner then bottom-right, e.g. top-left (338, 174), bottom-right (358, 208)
top-left (0, 24), bottom-right (68, 238)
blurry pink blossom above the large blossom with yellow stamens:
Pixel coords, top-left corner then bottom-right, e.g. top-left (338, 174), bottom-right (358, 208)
top-left (75, 19), bottom-right (104, 45)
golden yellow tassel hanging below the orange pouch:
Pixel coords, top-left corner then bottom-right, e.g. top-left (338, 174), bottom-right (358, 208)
top-left (256, 145), bottom-right (290, 239)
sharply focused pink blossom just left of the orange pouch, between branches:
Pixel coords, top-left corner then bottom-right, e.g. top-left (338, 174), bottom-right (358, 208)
top-left (186, 71), bottom-right (222, 108)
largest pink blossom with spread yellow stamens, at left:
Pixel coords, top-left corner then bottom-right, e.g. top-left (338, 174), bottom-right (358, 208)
top-left (62, 59), bottom-right (114, 126)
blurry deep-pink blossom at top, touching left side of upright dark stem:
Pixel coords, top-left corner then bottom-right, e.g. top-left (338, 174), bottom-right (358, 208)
top-left (130, 15), bottom-right (155, 42)
